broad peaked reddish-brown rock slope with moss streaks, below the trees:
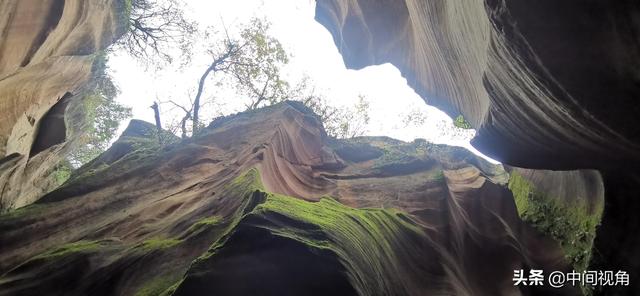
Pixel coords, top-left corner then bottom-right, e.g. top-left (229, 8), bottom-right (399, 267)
top-left (0, 103), bottom-right (579, 295)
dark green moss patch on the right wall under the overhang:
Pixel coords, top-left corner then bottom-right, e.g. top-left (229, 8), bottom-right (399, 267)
top-left (509, 172), bottom-right (602, 294)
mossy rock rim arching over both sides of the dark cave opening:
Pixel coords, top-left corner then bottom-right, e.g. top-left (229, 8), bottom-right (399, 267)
top-left (178, 169), bottom-right (428, 295)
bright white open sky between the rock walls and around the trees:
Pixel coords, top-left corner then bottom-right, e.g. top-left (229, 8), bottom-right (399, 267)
top-left (109, 0), bottom-right (498, 162)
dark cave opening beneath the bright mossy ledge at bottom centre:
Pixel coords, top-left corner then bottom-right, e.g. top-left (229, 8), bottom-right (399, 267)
top-left (174, 225), bottom-right (357, 296)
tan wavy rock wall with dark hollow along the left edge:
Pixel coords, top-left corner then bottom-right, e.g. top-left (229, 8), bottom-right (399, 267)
top-left (0, 0), bottom-right (124, 212)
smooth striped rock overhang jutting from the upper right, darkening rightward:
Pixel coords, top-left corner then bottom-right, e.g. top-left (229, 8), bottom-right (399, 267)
top-left (316, 0), bottom-right (640, 169)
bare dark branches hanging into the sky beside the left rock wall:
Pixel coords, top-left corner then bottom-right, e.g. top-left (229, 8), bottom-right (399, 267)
top-left (117, 0), bottom-right (197, 65)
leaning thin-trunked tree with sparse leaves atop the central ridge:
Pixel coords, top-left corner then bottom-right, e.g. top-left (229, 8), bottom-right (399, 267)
top-left (162, 18), bottom-right (288, 136)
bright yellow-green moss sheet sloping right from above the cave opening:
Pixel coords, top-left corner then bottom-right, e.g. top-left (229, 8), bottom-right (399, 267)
top-left (251, 193), bottom-right (426, 295)
